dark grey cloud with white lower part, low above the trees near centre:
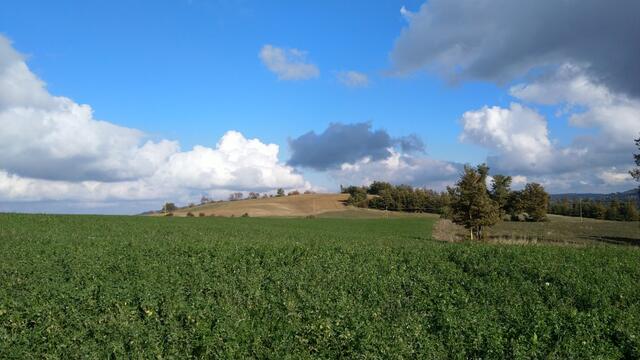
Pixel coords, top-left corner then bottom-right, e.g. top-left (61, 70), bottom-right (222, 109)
top-left (289, 123), bottom-right (462, 190)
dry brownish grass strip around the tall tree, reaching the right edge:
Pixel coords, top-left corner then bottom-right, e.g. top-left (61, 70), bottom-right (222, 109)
top-left (433, 215), bottom-right (640, 246)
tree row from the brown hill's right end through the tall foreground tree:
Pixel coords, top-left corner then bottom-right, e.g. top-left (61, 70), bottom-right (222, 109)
top-left (340, 164), bottom-right (549, 238)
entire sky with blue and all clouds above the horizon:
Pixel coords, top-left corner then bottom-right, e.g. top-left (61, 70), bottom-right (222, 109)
top-left (0, 0), bottom-right (640, 214)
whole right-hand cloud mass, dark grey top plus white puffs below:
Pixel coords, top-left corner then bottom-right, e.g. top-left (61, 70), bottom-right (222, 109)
top-left (391, 0), bottom-right (640, 191)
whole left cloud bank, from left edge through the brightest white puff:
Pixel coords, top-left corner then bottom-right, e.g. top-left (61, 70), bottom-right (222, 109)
top-left (0, 36), bottom-right (310, 210)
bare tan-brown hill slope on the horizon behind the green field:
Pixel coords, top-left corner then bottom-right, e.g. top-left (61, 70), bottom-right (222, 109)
top-left (164, 194), bottom-right (353, 217)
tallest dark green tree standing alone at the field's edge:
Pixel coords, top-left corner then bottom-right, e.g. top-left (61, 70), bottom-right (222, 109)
top-left (447, 165), bottom-right (500, 240)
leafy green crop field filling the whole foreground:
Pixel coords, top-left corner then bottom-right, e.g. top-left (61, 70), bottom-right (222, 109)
top-left (0, 214), bottom-right (640, 359)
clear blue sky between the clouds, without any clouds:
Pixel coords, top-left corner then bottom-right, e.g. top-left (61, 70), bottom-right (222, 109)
top-left (0, 0), bottom-right (496, 161)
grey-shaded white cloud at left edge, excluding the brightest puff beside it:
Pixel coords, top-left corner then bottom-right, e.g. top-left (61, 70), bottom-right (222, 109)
top-left (0, 36), bottom-right (177, 181)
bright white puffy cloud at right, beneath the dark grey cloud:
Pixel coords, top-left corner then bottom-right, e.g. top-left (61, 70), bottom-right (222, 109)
top-left (460, 74), bottom-right (640, 192)
